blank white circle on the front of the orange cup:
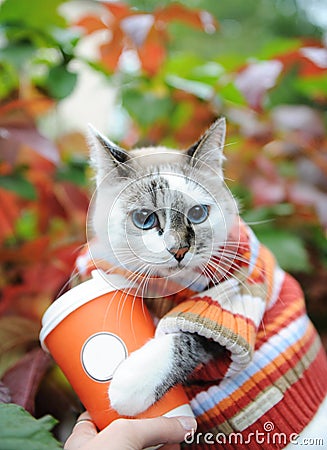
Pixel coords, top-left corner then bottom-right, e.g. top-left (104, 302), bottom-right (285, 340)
top-left (81, 332), bottom-right (128, 382)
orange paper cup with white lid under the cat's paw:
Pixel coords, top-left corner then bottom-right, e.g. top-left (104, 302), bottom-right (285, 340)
top-left (40, 270), bottom-right (193, 430)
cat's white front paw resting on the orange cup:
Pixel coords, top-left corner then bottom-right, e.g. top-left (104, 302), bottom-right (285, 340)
top-left (109, 334), bottom-right (174, 416)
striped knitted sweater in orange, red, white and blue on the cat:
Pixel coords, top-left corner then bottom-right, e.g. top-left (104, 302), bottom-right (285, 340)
top-left (77, 221), bottom-right (327, 449)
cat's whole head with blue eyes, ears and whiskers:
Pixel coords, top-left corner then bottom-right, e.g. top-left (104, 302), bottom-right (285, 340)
top-left (90, 119), bottom-right (237, 288)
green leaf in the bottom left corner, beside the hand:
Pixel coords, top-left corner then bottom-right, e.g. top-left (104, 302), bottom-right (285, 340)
top-left (0, 403), bottom-right (62, 450)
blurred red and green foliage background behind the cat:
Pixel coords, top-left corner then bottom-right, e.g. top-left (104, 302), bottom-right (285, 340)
top-left (0, 0), bottom-right (327, 450)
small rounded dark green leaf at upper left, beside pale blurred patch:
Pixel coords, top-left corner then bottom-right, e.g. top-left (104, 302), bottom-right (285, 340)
top-left (45, 66), bottom-right (77, 100)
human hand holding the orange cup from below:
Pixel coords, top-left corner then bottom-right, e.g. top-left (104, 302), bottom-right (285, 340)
top-left (64, 412), bottom-right (197, 450)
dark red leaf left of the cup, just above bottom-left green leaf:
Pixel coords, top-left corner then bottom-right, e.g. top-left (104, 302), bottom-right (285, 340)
top-left (3, 348), bottom-right (51, 414)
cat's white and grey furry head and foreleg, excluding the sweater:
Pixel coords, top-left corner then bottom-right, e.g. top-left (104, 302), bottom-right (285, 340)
top-left (91, 119), bottom-right (231, 415)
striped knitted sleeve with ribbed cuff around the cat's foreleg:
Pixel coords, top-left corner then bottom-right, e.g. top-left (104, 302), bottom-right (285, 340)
top-left (156, 246), bottom-right (282, 375)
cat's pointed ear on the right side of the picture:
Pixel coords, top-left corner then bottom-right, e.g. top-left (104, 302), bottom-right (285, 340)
top-left (187, 118), bottom-right (226, 175)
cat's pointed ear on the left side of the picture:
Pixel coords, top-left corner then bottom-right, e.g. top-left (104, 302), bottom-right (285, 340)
top-left (88, 124), bottom-right (131, 184)
